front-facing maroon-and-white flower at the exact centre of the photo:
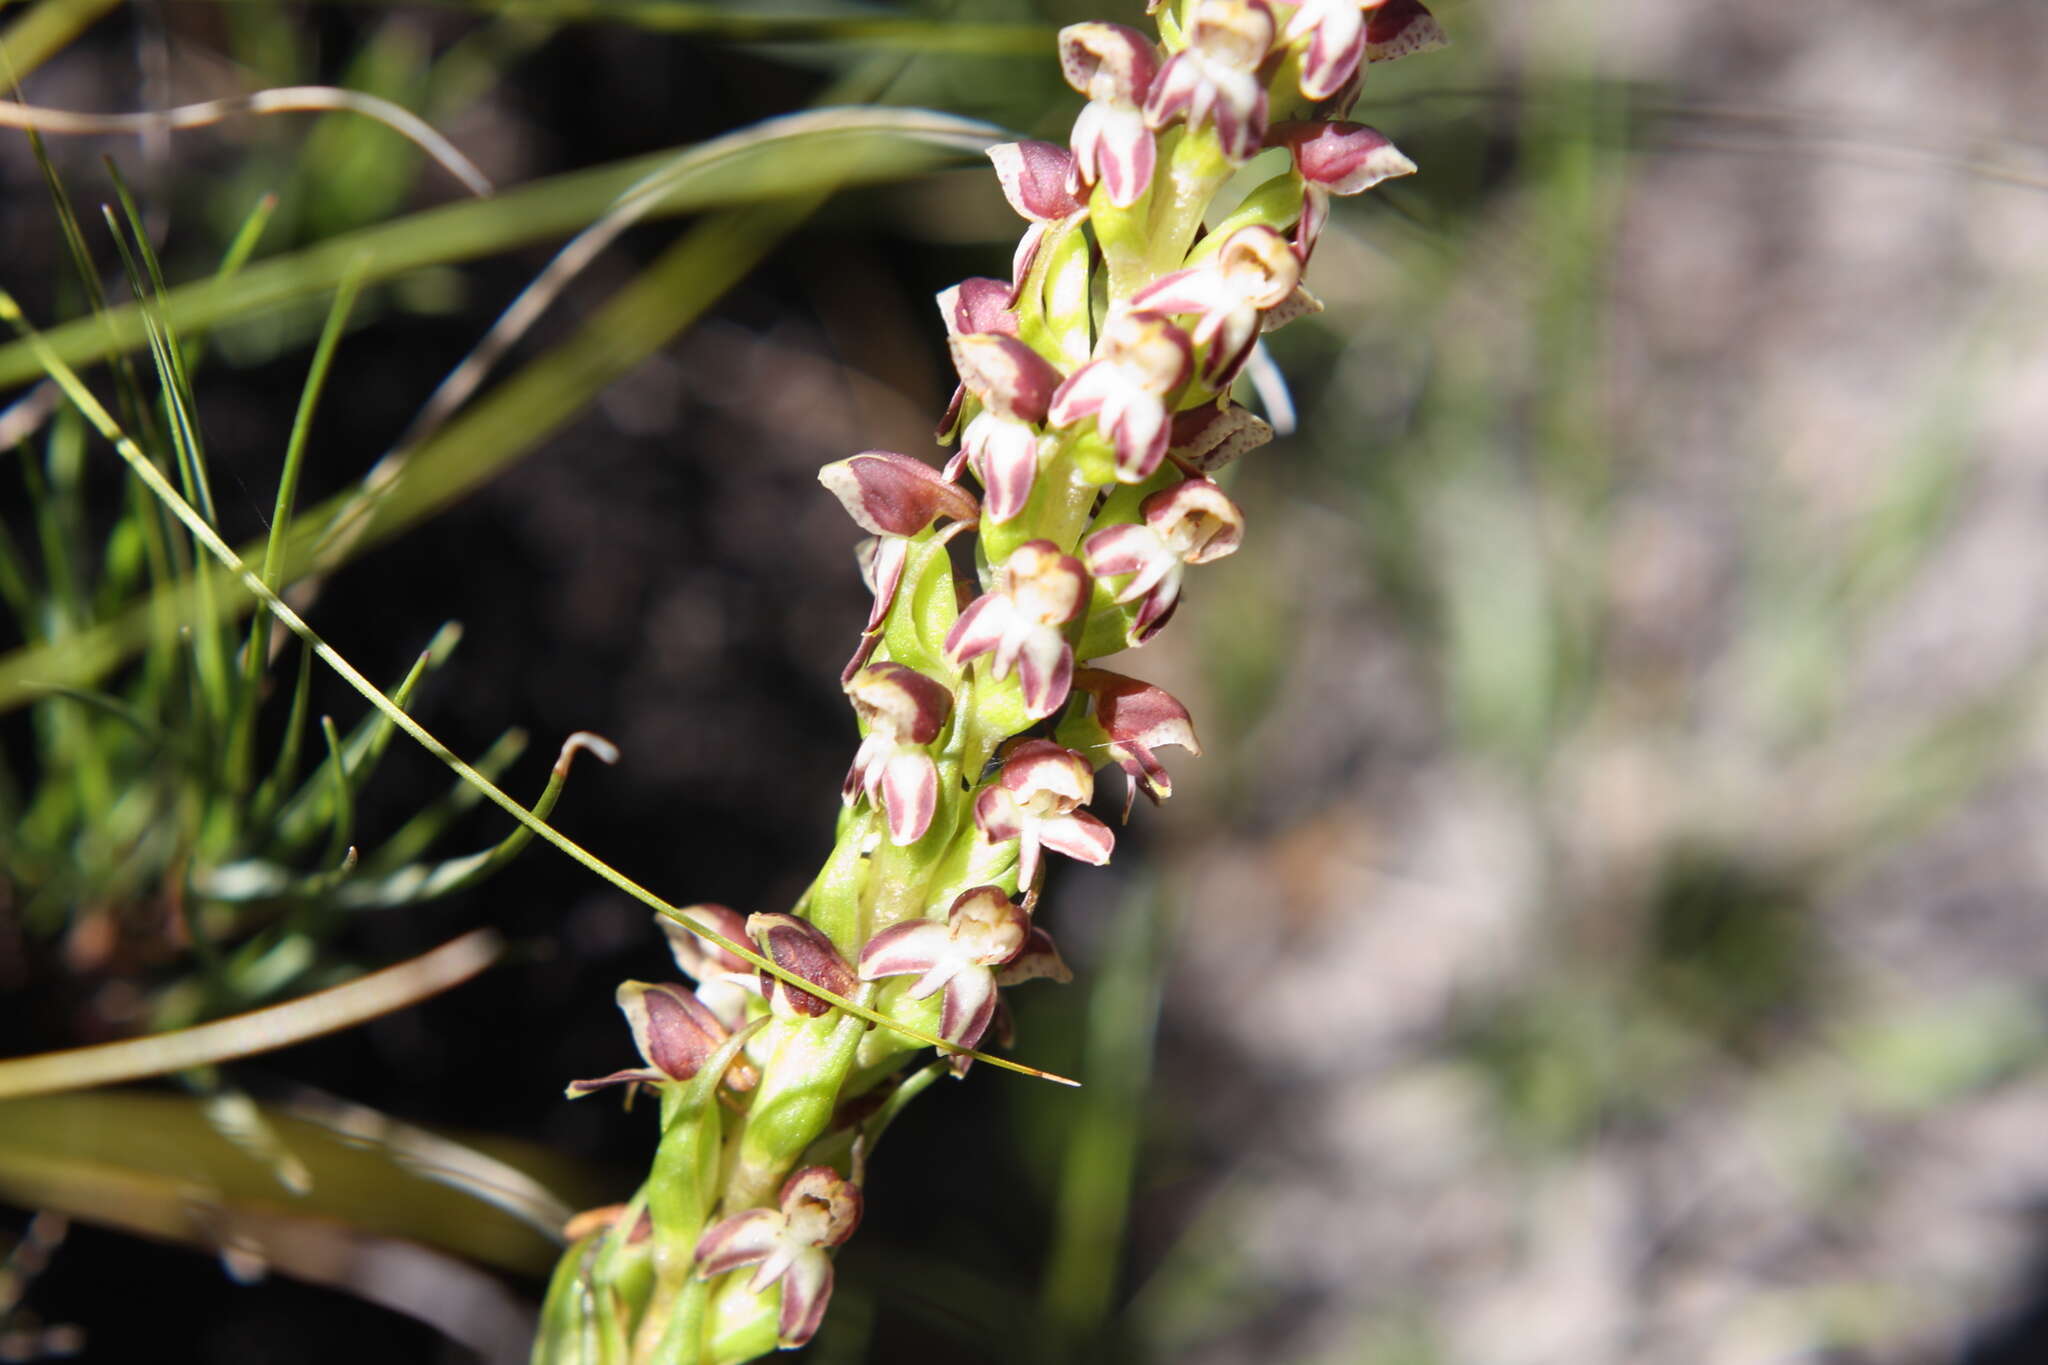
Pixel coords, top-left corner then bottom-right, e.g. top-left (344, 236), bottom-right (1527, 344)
top-left (946, 540), bottom-right (1092, 718)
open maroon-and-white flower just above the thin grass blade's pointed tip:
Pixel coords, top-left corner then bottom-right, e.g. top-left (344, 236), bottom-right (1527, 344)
top-left (860, 886), bottom-right (1030, 1048)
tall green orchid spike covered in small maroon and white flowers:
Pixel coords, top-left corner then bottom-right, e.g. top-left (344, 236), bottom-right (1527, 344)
top-left (535, 0), bottom-right (1442, 1365)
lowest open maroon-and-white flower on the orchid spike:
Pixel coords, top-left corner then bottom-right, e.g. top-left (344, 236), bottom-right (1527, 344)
top-left (696, 1166), bottom-right (860, 1349)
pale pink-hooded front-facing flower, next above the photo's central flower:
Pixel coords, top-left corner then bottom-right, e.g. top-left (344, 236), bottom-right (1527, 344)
top-left (1047, 311), bottom-right (1194, 483)
